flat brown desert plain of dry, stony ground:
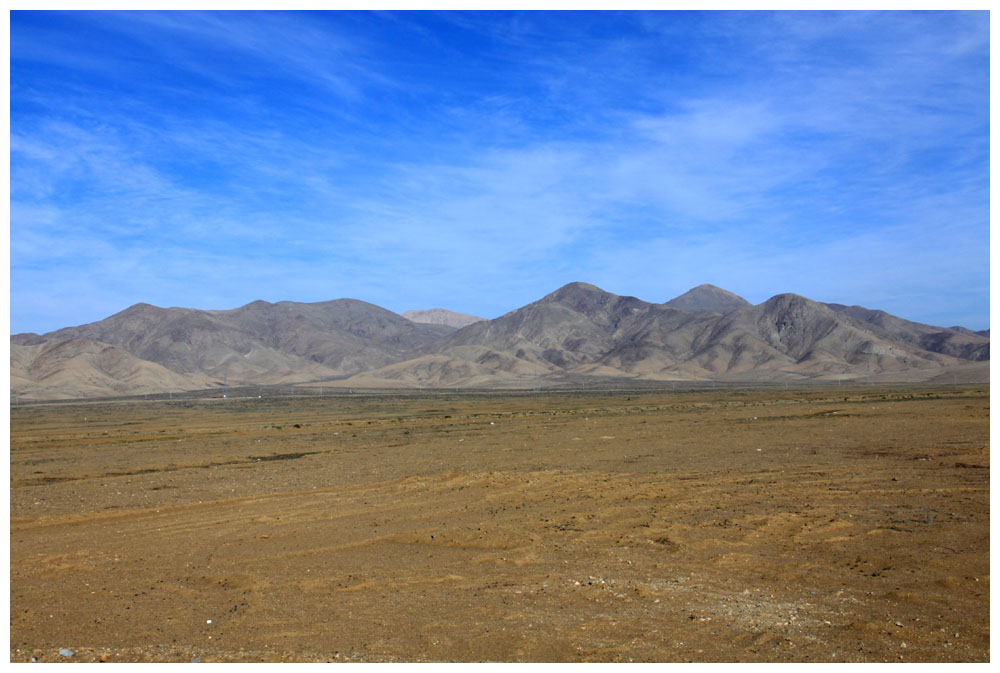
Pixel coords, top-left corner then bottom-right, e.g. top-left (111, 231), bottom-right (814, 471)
top-left (10, 385), bottom-right (990, 662)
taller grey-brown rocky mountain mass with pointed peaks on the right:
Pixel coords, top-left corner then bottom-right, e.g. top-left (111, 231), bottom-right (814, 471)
top-left (352, 283), bottom-right (988, 385)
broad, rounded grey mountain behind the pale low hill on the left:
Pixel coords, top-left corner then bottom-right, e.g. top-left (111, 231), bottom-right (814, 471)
top-left (11, 299), bottom-right (454, 395)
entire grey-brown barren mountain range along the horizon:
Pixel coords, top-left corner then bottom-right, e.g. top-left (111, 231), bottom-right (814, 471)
top-left (11, 283), bottom-right (989, 399)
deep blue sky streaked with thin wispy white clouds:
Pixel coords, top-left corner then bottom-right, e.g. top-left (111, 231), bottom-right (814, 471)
top-left (10, 11), bottom-right (989, 333)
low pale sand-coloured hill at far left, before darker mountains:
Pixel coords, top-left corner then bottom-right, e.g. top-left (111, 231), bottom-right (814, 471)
top-left (10, 339), bottom-right (216, 399)
